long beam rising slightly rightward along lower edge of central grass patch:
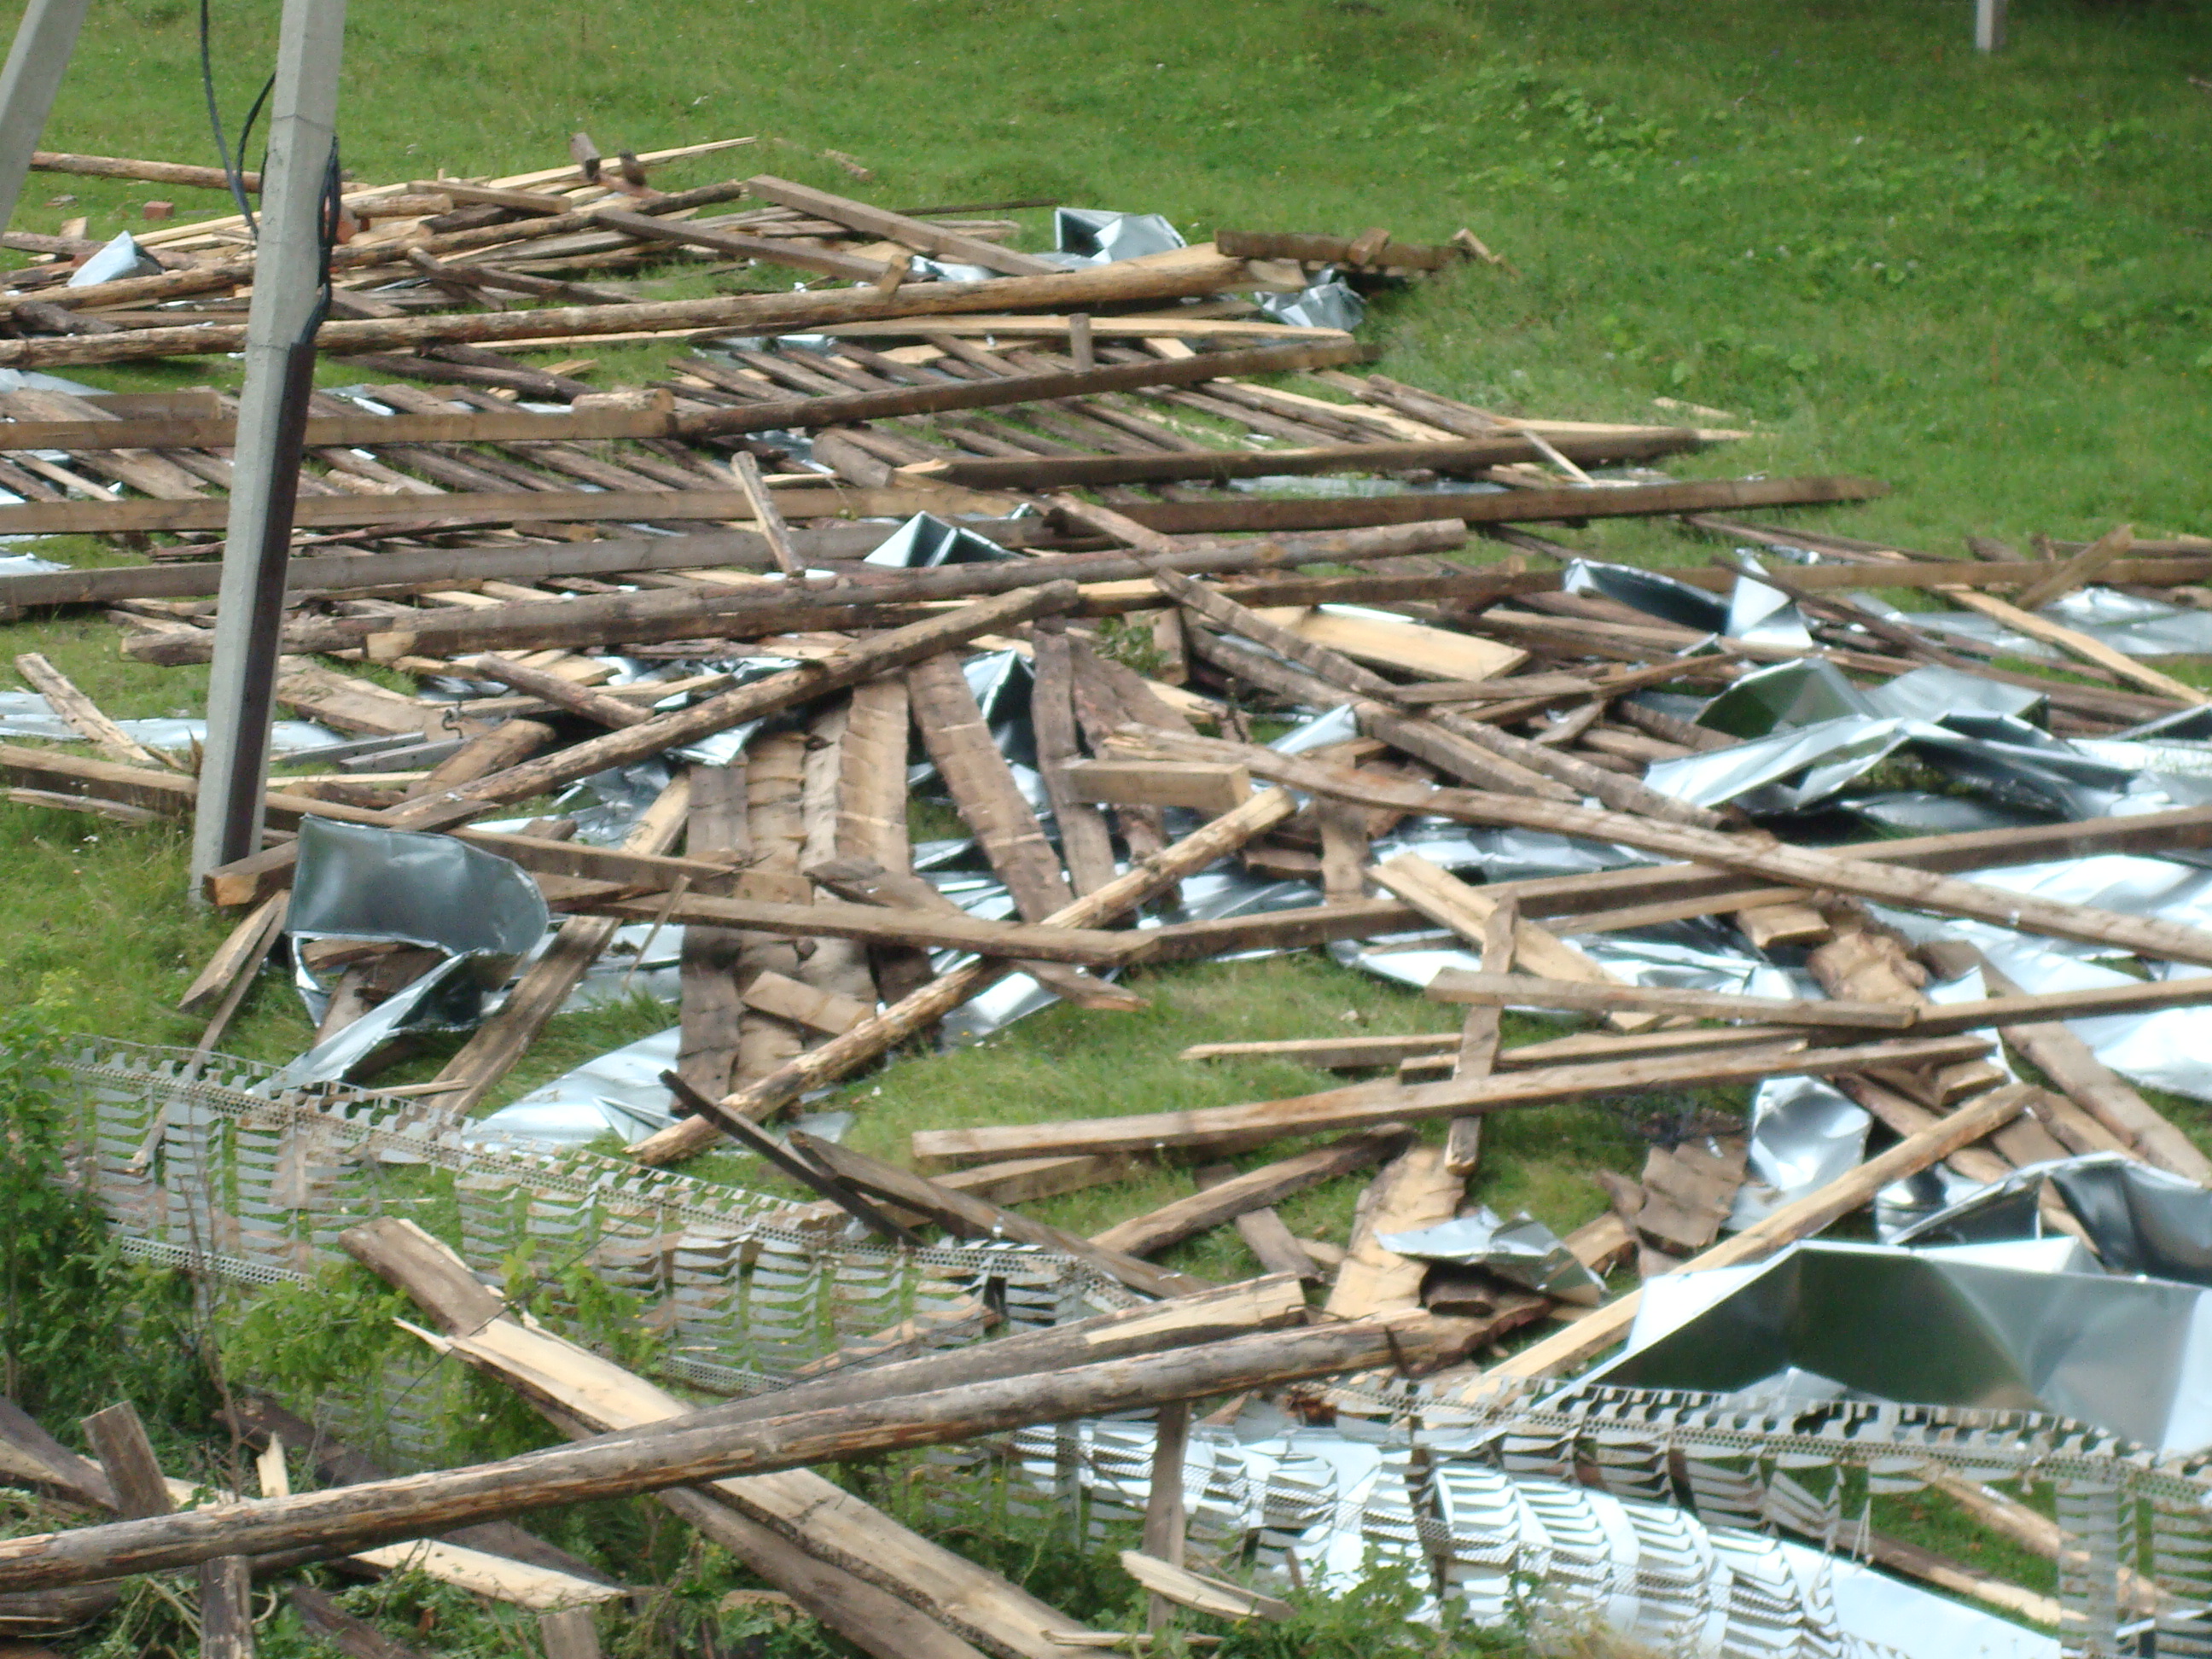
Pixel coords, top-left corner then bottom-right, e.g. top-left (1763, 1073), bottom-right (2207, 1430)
top-left (913, 1038), bottom-right (1987, 1163)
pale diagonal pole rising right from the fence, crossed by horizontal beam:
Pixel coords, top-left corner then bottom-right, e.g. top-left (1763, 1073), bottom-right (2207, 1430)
top-left (631, 789), bottom-right (1296, 1163)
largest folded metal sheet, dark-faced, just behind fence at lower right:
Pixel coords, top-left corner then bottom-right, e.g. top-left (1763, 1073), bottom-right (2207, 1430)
top-left (1599, 1243), bottom-right (2212, 1451)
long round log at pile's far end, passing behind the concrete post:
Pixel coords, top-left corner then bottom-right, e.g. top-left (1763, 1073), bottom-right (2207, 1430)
top-left (0, 248), bottom-right (1265, 369)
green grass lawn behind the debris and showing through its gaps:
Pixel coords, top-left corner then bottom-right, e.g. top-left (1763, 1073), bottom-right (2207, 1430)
top-left (0, 0), bottom-right (2212, 1654)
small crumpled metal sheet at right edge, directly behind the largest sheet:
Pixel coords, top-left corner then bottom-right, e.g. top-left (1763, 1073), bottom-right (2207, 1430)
top-left (1891, 1152), bottom-right (2212, 1288)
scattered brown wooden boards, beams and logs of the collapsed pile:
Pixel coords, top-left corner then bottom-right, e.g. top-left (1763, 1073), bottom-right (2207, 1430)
top-left (0, 133), bottom-right (2212, 1659)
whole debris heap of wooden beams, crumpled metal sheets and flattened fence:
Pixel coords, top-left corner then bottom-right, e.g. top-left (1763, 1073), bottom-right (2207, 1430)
top-left (0, 133), bottom-right (2212, 1659)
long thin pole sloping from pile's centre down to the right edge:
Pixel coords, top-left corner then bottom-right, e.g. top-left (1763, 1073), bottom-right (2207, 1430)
top-left (1141, 732), bottom-right (2212, 964)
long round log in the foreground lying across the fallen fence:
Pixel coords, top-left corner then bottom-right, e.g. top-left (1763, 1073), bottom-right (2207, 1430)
top-left (0, 1314), bottom-right (1482, 1591)
